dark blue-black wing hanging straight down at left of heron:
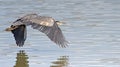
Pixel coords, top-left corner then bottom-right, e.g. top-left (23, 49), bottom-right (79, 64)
top-left (12, 25), bottom-right (27, 47)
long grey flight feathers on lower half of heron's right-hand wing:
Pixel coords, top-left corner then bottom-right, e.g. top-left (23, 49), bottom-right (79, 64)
top-left (32, 23), bottom-right (68, 47)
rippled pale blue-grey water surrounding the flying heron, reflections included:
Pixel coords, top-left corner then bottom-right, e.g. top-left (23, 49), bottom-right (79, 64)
top-left (0, 0), bottom-right (120, 67)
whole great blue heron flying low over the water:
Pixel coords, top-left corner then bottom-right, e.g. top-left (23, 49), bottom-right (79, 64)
top-left (6, 14), bottom-right (68, 47)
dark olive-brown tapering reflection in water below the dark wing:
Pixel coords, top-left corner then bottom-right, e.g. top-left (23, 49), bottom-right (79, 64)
top-left (14, 50), bottom-right (29, 67)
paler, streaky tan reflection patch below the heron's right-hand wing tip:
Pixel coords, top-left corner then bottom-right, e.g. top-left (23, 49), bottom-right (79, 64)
top-left (50, 56), bottom-right (69, 67)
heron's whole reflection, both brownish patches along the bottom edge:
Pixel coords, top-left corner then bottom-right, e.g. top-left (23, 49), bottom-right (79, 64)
top-left (14, 50), bottom-right (69, 67)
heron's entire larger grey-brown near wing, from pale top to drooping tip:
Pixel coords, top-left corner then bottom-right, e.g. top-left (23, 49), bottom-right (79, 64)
top-left (14, 14), bottom-right (68, 47)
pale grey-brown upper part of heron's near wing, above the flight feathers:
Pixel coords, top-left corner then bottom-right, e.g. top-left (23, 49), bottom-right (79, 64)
top-left (17, 14), bottom-right (54, 27)
